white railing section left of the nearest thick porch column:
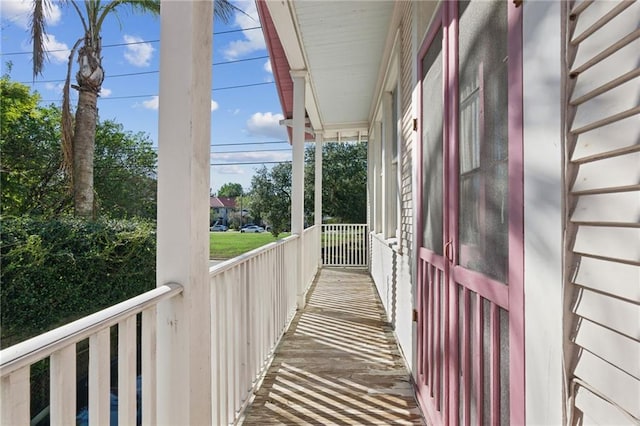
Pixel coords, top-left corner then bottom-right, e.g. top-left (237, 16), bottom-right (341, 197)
top-left (0, 284), bottom-right (182, 425)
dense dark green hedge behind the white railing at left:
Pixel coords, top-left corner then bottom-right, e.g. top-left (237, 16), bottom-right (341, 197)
top-left (0, 217), bottom-right (156, 347)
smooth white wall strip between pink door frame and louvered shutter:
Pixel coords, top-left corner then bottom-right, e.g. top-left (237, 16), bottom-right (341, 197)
top-left (523, 2), bottom-right (563, 425)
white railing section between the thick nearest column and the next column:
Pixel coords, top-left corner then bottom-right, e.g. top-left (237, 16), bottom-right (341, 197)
top-left (210, 235), bottom-right (302, 425)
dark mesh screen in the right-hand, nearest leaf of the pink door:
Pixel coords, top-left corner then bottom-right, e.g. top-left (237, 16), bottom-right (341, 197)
top-left (458, 1), bottom-right (509, 283)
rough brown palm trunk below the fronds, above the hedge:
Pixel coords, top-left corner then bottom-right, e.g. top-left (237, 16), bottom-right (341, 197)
top-left (73, 90), bottom-right (98, 219)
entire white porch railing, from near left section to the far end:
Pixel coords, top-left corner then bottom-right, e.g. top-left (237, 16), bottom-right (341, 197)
top-left (0, 225), bottom-right (344, 425)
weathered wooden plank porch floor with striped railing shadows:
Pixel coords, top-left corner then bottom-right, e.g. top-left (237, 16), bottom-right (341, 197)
top-left (243, 269), bottom-right (424, 425)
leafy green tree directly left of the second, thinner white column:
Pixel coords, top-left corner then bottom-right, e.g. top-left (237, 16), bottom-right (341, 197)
top-left (248, 163), bottom-right (291, 237)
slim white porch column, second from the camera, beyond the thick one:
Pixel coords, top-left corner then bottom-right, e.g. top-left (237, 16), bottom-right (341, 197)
top-left (291, 70), bottom-right (307, 309)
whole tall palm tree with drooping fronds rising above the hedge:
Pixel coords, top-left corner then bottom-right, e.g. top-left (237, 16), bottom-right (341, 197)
top-left (30, 0), bottom-right (239, 218)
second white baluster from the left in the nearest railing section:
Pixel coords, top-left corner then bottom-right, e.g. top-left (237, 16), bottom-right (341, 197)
top-left (50, 344), bottom-right (75, 425)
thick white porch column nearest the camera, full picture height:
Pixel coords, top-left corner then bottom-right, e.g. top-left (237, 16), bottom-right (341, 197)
top-left (156, 1), bottom-right (213, 425)
